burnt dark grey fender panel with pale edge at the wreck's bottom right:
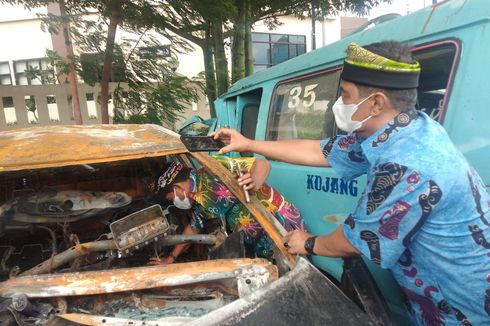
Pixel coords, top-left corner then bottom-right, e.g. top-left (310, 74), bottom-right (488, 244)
top-left (186, 258), bottom-right (379, 326)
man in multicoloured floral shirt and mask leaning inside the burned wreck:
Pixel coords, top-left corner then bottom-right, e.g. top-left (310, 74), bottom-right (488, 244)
top-left (157, 156), bottom-right (306, 264)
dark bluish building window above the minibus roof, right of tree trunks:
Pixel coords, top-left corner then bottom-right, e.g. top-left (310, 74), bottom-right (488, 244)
top-left (252, 33), bottom-right (306, 71)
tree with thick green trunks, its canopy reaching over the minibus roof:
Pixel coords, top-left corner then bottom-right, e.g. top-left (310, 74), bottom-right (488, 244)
top-left (153, 0), bottom-right (391, 111)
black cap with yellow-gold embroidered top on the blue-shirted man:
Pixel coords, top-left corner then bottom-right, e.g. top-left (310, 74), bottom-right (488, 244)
top-left (340, 43), bottom-right (420, 89)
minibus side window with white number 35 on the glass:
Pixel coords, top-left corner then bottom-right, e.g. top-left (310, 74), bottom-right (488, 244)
top-left (266, 68), bottom-right (340, 140)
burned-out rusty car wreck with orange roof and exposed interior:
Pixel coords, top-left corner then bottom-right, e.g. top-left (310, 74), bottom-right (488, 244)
top-left (0, 125), bottom-right (375, 325)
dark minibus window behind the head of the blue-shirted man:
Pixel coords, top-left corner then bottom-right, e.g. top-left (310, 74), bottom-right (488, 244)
top-left (413, 41), bottom-right (457, 121)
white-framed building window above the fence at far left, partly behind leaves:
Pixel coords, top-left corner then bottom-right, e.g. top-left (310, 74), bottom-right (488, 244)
top-left (14, 58), bottom-right (55, 85)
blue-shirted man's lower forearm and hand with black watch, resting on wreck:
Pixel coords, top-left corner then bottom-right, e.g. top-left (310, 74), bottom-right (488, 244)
top-left (283, 225), bottom-right (361, 257)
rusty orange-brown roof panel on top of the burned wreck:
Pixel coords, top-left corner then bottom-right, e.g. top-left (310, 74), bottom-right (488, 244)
top-left (0, 124), bottom-right (187, 172)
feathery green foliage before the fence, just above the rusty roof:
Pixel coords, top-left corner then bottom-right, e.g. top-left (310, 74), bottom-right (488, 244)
top-left (114, 37), bottom-right (203, 125)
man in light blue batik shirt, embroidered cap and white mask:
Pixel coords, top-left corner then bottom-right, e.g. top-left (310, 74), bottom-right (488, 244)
top-left (215, 42), bottom-right (490, 325)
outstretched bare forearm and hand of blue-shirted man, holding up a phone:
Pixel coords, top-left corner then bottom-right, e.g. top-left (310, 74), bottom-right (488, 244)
top-left (212, 128), bottom-right (329, 166)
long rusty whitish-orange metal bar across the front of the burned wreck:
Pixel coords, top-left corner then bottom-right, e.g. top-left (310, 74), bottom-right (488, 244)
top-left (0, 258), bottom-right (278, 298)
